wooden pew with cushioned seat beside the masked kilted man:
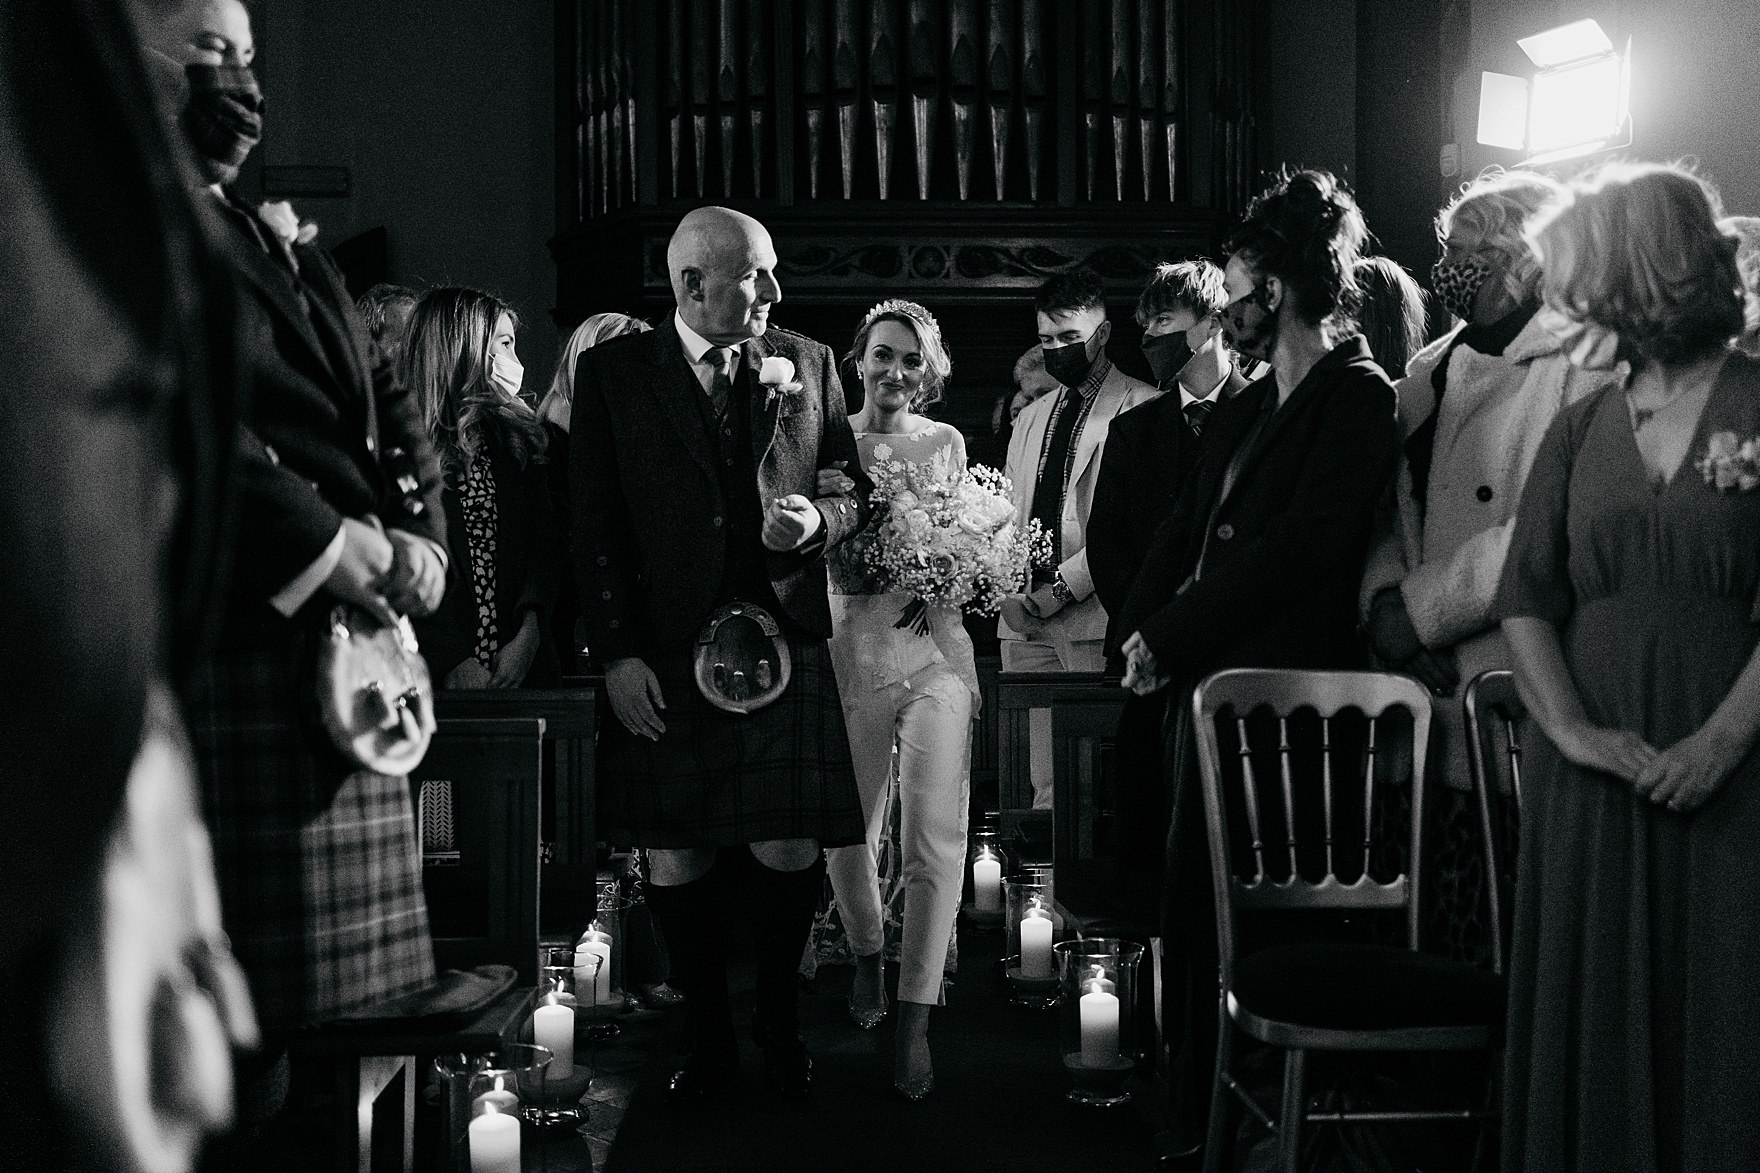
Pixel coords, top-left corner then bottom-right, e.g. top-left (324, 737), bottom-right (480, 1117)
top-left (290, 717), bottom-right (544, 1173)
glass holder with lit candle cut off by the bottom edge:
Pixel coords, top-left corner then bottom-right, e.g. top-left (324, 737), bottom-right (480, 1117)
top-left (435, 1043), bottom-right (551, 1173)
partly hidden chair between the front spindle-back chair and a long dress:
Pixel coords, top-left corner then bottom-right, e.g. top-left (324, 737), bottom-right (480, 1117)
top-left (1464, 671), bottom-right (1528, 974)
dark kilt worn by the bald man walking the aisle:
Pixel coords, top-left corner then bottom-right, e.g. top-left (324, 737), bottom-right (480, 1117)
top-left (598, 632), bottom-right (866, 847)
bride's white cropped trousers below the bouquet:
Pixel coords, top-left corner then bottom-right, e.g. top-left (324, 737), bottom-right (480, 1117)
top-left (825, 662), bottom-right (972, 1006)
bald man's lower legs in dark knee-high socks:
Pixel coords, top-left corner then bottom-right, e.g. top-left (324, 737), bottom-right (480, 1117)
top-left (646, 849), bottom-right (824, 1066)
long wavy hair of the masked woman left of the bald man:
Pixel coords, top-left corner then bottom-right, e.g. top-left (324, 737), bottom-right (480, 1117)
top-left (400, 285), bottom-right (546, 484)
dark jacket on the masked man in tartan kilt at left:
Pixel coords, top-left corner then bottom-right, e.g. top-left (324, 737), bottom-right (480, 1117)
top-left (207, 189), bottom-right (445, 646)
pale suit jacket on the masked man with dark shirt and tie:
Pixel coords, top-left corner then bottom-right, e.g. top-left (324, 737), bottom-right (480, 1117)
top-left (996, 366), bottom-right (1162, 639)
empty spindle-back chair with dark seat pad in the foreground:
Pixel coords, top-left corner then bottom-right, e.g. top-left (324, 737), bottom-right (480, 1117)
top-left (1192, 669), bottom-right (1503, 1173)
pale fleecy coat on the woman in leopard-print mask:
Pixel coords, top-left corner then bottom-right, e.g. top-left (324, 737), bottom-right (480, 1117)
top-left (1359, 315), bottom-right (1621, 787)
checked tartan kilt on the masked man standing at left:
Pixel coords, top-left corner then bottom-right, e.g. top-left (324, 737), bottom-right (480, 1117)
top-left (187, 631), bottom-right (435, 1032)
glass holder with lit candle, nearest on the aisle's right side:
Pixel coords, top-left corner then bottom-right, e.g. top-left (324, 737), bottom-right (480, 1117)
top-left (1054, 937), bottom-right (1142, 1106)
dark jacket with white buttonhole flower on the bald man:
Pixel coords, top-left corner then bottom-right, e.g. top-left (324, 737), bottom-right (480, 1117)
top-left (568, 309), bottom-right (871, 662)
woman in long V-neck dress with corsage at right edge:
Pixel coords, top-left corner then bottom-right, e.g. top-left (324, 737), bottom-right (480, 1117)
top-left (1498, 164), bottom-right (1760, 1173)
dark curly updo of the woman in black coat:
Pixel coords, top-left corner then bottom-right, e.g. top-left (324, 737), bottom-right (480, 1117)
top-left (1225, 171), bottom-right (1369, 326)
